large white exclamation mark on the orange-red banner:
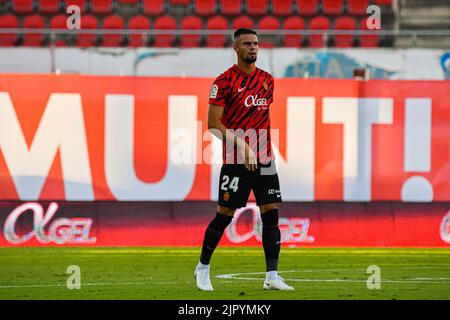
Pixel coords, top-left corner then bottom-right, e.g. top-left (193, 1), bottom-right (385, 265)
top-left (402, 98), bottom-right (433, 202)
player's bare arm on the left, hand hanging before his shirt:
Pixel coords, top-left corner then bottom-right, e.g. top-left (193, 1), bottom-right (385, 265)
top-left (208, 104), bottom-right (257, 171)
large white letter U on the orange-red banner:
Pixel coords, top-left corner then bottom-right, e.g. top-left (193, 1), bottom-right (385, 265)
top-left (105, 94), bottom-right (197, 201)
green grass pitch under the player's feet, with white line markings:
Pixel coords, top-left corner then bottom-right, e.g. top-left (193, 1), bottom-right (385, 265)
top-left (0, 247), bottom-right (450, 300)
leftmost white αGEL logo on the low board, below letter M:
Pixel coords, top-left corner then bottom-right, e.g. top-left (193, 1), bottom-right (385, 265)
top-left (3, 202), bottom-right (97, 244)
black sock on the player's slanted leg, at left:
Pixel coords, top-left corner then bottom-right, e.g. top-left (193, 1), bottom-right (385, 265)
top-left (200, 212), bottom-right (233, 264)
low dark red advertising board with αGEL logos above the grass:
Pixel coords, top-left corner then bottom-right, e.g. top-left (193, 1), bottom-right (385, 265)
top-left (0, 202), bottom-right (450, 247)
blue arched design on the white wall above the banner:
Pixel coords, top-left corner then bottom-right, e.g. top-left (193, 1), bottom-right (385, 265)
top-left (284, 52), bottom-right (395, 79)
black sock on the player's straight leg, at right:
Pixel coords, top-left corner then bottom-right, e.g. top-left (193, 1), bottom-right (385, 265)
top-left (261, 209), bottom-right (281, 272)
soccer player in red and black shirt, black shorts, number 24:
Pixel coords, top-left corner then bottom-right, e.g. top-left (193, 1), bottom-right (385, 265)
top-left (194, 29), bottom-right (294, 291)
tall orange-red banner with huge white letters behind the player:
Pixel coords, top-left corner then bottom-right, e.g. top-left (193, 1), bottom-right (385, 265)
top-left (0, 75), bottom-right (450, 202)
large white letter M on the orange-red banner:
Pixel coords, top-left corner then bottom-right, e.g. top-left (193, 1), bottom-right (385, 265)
top-left (0, 92), bottom-right (94, 200)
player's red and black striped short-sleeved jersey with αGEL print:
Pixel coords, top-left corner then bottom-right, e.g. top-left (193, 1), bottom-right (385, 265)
top-left (209, 65), bottom-right (274, 163)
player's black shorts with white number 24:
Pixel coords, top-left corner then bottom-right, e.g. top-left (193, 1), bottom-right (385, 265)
top-left (219, 161), bottom-right (281, 209)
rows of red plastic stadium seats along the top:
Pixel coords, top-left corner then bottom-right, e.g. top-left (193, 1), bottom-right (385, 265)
top-left (0, 0), bottom-right (396, 47)
